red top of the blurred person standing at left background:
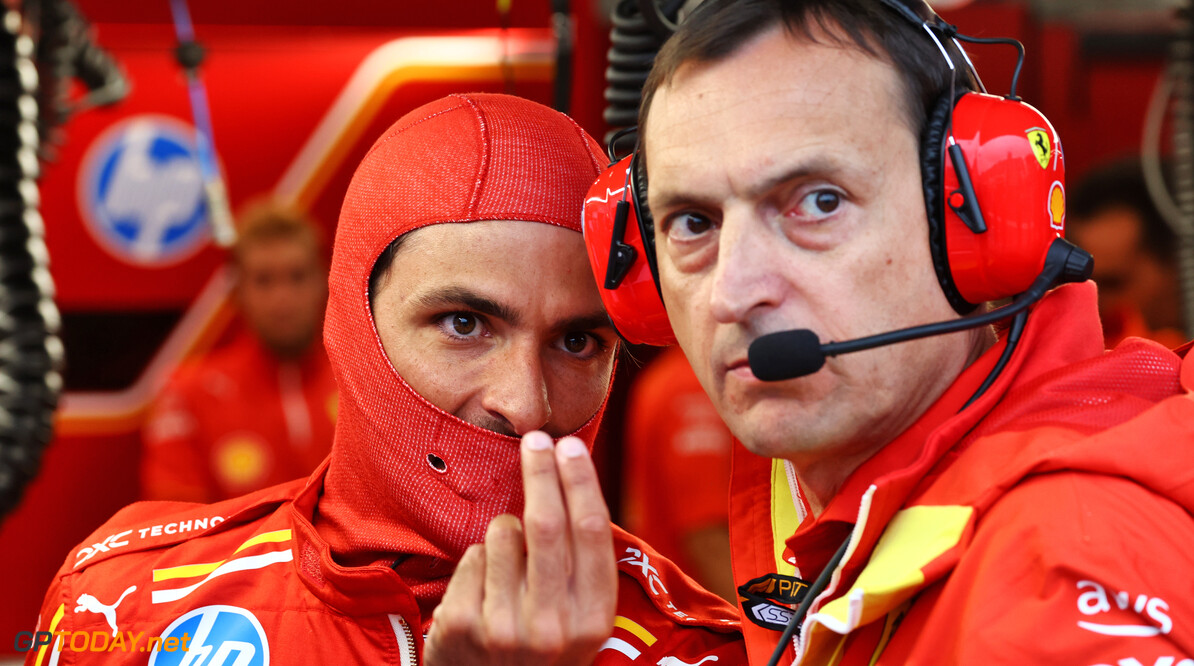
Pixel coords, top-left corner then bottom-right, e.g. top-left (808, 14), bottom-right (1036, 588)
top-left (141, 331), bottom-right (337, 502)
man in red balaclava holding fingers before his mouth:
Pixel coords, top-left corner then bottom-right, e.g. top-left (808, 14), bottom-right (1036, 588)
top-left (26, 94), bottom-right (745, 666)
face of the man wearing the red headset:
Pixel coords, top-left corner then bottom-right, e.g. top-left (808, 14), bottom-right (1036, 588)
top-left (645, 27), bottom-right (979, 469)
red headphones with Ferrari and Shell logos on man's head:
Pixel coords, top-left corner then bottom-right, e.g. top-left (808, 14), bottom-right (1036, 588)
top-left (583, 0), bottom-right (1065, 345)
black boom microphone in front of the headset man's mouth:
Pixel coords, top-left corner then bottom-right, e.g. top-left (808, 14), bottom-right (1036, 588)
top-left (746, 239), bottom-right (1095, 382)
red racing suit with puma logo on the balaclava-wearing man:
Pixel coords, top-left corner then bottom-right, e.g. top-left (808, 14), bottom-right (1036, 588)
top-left (25, 464), bottom-right (746, 666)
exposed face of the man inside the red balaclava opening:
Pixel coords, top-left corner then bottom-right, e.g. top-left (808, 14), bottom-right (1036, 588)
top-left (373, 221), bottom-right (617, 437)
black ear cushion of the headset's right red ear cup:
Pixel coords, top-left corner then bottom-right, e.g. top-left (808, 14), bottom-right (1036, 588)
top-left (921, 93), bottom-right (977, 314)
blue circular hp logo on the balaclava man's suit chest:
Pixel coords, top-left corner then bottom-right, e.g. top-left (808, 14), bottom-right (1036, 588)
top-left (149, 606), bottom-right (270, 666)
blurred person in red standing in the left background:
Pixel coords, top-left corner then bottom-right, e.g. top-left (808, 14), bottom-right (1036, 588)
top-left (141, 201), bottom-right (336, 502)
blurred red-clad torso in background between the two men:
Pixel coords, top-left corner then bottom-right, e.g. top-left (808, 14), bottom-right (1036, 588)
top-left (623, 346), bottom-right (736, 602)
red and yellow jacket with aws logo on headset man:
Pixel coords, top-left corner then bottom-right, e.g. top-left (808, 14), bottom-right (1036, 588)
top-left (731, 283), bottom-right (1194, 666)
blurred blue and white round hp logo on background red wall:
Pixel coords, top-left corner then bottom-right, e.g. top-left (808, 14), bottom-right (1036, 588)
top-left (79, 116), bottom-right (209, 266)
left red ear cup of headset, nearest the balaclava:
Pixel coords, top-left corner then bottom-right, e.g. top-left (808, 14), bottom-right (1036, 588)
top-left (581, 156), bottom-right (676, 346)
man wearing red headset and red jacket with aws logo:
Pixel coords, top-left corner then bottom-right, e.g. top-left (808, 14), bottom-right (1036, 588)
top-left (585, 0), bottom-right (1194, 666)
